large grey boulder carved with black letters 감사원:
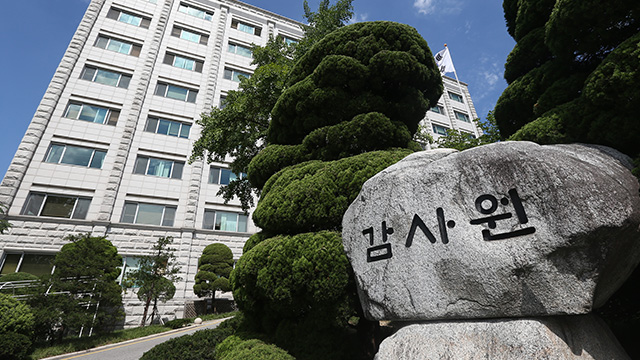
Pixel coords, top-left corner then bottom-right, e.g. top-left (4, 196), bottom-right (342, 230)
top-left (342, 142), bottom-right (640, 359)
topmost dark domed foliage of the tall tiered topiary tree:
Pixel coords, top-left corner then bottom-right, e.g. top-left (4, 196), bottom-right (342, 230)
top-left (267, 21), bottom-right (442, 144)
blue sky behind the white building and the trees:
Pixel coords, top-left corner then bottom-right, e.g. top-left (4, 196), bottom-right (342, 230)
top-left (0, 0), bottom-right (515, 177)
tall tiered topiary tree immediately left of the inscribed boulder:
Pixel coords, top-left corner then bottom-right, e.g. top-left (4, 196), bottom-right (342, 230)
top-left (231, 22), bottom-right (443, 359)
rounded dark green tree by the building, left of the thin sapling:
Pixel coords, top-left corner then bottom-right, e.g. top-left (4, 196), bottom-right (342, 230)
top-left (49, 233), bottom-right (123, 331)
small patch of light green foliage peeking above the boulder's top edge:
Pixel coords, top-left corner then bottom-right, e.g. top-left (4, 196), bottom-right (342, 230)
top-left (436, 111), bottom-right (500, 151)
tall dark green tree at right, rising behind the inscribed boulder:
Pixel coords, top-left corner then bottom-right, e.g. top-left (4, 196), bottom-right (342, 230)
top-left (495, 0), bottom-right (640, 358)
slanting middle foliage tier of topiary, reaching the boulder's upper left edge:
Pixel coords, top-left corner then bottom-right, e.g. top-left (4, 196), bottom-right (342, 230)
top-left (253, 149), bottom-right (411, 234)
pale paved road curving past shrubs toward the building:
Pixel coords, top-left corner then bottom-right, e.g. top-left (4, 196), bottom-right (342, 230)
top-left (45, 319), bottom-right (225, 360)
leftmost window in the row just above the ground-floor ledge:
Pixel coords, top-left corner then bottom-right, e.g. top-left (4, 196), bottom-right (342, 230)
top-left (20, 193), bottom-right (91, 219)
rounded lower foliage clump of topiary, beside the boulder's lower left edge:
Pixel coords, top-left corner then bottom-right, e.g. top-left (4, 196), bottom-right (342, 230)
top-left (231, 231), bottom-right (357, 330)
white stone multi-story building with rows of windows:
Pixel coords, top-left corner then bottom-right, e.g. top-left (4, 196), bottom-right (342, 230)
top-left (0, 0), bottom-right (478, 325)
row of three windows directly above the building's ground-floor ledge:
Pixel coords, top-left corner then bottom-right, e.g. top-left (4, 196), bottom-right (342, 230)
top-left (20, 192), bottom-right (248, 232)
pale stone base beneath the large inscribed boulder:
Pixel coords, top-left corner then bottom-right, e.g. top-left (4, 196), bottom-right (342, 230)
top-left (375, 314), bottom-right (630, 360)
